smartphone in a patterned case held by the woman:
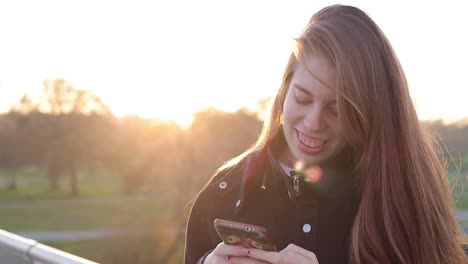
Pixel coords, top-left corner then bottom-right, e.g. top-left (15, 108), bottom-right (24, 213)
top-left (213, 219), bottom-right (277, 251)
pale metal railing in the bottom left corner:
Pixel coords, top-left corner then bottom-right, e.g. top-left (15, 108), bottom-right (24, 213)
top-left (0, 229), bottom-right (98, 264)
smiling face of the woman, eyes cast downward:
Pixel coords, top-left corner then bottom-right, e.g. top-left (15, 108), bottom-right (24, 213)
top-left (281, 55), bottom-right (345, 165)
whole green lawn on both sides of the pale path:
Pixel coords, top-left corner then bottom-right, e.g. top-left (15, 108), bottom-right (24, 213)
top-left (0, 169), bottom-right (186, 264)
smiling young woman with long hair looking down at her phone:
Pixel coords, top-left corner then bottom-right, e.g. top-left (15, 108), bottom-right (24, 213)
top-left (185, 5), bottom-right (467, 264)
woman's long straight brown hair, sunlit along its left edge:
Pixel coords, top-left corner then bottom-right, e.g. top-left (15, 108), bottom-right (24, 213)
top-left (221, 5), bottom-right (467, 264)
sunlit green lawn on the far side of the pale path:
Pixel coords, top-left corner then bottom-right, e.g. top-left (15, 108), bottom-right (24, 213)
top-left (0, 168), bottom-right (177, 231)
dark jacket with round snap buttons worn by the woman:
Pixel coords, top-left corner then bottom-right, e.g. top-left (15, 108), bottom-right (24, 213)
top-left (185, 148), bottom-right (358, 264)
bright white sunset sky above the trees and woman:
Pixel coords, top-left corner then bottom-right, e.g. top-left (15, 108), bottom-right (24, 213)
top-left (0, 0), bottom-right (468, 128)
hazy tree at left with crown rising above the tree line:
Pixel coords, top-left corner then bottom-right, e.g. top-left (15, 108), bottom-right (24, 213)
top-left (11, 79), bottom-right (112, 196)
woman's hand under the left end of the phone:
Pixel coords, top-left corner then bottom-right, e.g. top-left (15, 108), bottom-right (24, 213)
top-left (203, 242), bottom-right (268, 264)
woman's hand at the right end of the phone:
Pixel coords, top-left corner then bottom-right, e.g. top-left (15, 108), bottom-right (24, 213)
top-left (247, 244), bottom-right (319, 264)
